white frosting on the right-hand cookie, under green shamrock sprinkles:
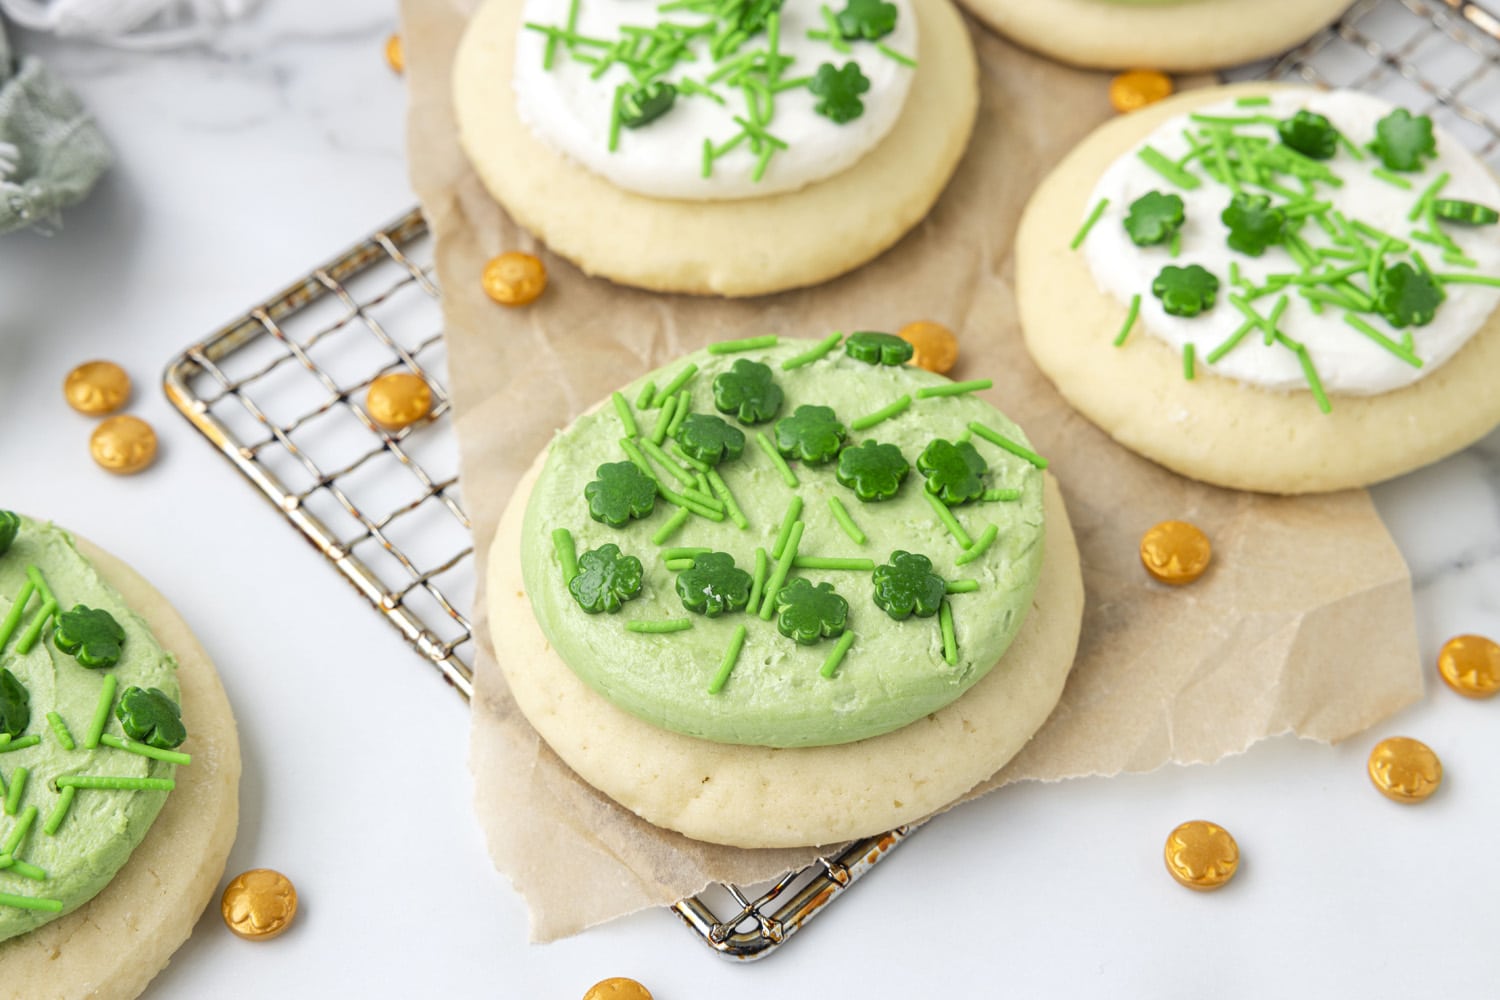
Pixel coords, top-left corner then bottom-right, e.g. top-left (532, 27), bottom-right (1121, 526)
top-left (1085, 90), bottom-right (1500, 394)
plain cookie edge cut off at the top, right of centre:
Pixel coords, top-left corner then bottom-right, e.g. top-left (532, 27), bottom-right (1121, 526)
top-left (960, 0), bottom-right (1352, 72)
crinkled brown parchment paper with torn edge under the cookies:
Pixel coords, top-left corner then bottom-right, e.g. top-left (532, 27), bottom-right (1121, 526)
top-left (402, 0), bottom-right (1422, 940)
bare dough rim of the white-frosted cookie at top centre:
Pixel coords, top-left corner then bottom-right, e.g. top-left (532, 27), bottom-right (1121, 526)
top-left (453, 0), bottom-right (978, 295)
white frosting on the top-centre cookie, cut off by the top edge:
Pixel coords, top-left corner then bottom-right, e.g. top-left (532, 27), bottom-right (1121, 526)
top-left (515, 0), bottom-right (917, 201)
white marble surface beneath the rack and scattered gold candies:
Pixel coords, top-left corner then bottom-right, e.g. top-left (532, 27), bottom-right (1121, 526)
top-left (0, 0), bottom-right (1500, 1000)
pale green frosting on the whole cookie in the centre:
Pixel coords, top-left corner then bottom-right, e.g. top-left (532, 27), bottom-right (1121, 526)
top-left (522, 339), bottom-right (1044, 747)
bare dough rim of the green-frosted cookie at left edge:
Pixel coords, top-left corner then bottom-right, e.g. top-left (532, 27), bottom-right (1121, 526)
top-left (0, 540), bottom-right (240, 1000)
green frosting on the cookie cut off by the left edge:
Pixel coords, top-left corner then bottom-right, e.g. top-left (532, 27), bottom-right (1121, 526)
top-left (0, 519), bottom-right (177, 940)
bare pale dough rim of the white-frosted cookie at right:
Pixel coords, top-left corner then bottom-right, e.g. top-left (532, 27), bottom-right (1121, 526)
top-left (1016, 84), bottom-right (1500, 493)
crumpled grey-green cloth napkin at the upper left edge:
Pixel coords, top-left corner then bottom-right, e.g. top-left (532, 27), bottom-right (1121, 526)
top-left (0, 24), bottom-right (111, 232)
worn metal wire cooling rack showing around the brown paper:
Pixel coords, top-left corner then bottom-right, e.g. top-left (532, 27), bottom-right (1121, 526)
top-left (165, 0), bottom-right (1500, 960)
